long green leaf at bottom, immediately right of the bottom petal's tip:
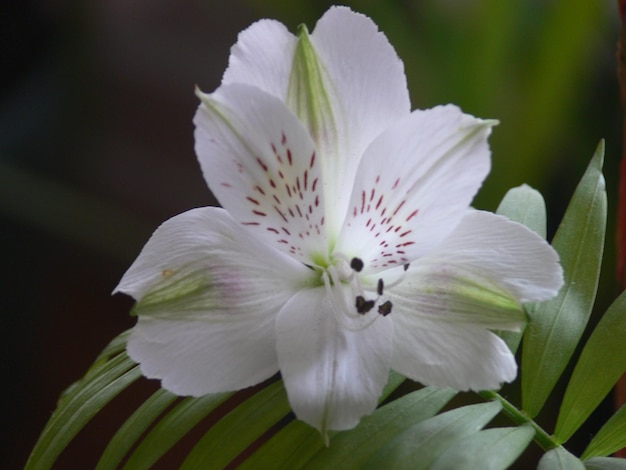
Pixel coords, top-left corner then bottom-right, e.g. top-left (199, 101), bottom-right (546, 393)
top-left (307, 387), bottom-right (456, 469)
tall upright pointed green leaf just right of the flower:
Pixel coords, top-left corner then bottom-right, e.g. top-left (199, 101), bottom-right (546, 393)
top-left (521, 142), bottom-right (607, 418)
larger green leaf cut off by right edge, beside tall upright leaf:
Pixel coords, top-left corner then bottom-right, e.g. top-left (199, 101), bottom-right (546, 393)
top-left (554, 292), bottom-right (626, 442)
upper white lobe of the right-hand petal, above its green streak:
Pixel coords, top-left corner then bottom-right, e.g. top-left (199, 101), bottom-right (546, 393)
top-left (416, 210), bottom-right (563, 302)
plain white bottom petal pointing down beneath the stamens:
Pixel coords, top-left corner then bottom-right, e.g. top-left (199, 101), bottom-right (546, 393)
top-left (276, 287), bottom-right (393, 434)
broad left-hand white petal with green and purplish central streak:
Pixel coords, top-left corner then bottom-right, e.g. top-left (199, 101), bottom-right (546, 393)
top-left (115, 208), bottom-right (311, 396)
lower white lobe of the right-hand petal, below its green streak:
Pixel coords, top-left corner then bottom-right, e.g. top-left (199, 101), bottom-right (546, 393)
top-left (390, 314), bottom-right (517, 390)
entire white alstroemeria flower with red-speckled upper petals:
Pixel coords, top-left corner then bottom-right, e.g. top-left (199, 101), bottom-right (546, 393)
top-left (116, 7), bottom-right (562, 433)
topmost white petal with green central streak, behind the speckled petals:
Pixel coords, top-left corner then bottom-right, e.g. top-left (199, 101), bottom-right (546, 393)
top-left (222, 7), bottom-right (410, 234)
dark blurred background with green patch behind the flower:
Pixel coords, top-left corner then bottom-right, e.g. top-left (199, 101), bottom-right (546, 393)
top-left (0, 0), bottom-right (621, 468)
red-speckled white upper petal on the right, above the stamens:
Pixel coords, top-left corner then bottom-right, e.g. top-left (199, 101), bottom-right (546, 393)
top-left (337, 105), bottom-right (493, 269)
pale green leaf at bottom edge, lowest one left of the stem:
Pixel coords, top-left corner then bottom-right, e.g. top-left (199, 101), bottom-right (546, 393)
top-left (430, 426), bottom-right (535, 470)
